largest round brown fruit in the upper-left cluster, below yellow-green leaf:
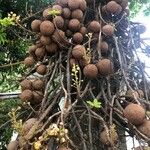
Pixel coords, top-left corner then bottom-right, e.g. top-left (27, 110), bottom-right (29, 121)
top-left (40, 21), bottom-right (55, 36)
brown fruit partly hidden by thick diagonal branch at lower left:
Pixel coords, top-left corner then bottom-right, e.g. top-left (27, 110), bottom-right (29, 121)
top-left (22, 118), bottom-right (37, 136)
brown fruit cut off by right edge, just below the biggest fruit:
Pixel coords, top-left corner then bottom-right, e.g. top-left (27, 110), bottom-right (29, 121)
top-left (138, 120), bottom-right (150, 138)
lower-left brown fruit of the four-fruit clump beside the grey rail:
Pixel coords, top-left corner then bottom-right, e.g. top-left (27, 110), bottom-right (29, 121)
top-left (19, 90), bottom-right (33, 102)
